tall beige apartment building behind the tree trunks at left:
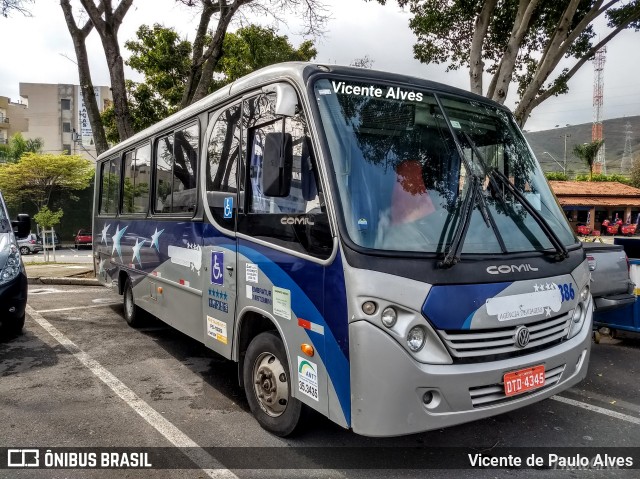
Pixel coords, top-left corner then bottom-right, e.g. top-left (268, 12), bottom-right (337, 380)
top-left (20, 83), bottom-right (112, 162)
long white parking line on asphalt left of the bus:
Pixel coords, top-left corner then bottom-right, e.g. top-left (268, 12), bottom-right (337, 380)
top-left (27, 305), bottom-right (238, 479)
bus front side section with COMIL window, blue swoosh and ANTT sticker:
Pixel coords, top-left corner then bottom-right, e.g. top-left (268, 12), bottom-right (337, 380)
top-left (237, 93), bottom-right (336, 424)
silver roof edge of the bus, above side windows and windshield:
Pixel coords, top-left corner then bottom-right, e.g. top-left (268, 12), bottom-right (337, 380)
top-left (98, 62), bottom-right (506, 161)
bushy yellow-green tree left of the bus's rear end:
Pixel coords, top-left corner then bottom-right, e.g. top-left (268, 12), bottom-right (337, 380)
top-left (0, 153), bottom-right (94, 210)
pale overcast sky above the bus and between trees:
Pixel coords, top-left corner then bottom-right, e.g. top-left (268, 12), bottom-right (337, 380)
top-left (0, 0), bottom-right (640, 134)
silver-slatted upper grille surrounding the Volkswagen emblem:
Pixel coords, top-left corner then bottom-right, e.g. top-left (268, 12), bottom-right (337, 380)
top-left (438, 312), bottom-right (571, 363)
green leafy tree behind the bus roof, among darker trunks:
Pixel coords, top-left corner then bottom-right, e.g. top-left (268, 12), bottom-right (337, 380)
top-left (102, 24), bottom-right (317, 141)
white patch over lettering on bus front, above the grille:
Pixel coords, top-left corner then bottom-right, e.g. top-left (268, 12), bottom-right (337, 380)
top-left (486, 283), bottom-right (562, 321)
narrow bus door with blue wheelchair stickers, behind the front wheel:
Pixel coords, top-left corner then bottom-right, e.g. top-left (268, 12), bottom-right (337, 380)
top-left (202, 103), bottom-right (242, 359)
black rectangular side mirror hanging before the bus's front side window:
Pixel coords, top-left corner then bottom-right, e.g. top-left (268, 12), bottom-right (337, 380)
top-left (262, 133), bottom-right (293, 198)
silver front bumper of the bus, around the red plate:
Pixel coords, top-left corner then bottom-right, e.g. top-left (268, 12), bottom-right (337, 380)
top-left (349, 302), bottom-right (593, 436)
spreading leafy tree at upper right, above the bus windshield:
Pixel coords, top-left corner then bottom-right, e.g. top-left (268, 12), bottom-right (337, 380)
top-left (367, 0), bottom-right (640, 126)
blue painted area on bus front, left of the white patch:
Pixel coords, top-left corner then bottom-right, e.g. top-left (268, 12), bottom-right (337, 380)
top-left (422, 282), bottom-right (513, 330)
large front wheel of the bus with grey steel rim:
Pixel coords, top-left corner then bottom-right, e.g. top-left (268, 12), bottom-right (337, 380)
top-left (242, 331), bottom-right (304, 437)
